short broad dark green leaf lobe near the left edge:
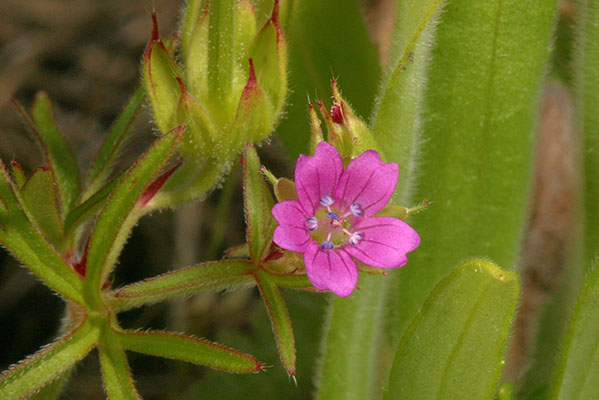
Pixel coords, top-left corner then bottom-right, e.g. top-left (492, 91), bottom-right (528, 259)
top-left (21, 168), bottom-right (63, 249)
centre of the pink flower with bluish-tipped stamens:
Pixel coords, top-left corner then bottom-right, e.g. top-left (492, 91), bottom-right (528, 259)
top-left (305, 196), bottom-right (364, 250)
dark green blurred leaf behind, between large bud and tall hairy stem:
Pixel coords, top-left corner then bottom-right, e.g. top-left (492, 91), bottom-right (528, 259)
top-left (271, 0), bottom-right (380, 159)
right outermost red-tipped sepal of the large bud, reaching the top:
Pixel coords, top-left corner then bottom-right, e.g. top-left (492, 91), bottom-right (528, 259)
top-left (249, 0), bottom-right (287, 117)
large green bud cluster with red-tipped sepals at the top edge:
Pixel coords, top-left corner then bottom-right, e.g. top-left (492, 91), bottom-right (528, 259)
top-left (143, 0), bottom-right (287, 164)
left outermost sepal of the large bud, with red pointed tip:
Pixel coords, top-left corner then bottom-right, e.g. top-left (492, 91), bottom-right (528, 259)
top-left (143, 22), bottom-right (181, 133)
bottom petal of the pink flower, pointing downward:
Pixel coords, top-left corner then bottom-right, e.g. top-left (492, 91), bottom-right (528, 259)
top-left (304, 241), bottom-right (358, 297)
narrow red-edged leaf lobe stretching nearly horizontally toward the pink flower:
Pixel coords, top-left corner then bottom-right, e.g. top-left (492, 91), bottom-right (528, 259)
top-left (107, 260), bottom-right (255, 312)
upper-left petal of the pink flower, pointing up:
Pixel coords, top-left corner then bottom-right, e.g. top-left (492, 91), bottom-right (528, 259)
top-left (295, 142), bottom-right (343, 215)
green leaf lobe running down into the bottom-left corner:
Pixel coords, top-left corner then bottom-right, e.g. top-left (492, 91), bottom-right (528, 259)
top-left (0, 321), bottom-right (99, 400)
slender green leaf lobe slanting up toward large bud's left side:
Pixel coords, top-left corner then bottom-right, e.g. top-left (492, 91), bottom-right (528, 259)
top-left (82, 85), bottom-right (146, 200)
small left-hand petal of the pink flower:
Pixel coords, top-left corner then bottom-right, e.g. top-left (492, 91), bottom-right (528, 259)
top-left (272, 200), bottom-right (316, 253)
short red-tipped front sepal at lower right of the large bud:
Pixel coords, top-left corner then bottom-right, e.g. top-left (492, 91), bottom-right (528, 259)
top-left (231, 59), bottom-right (273, 142)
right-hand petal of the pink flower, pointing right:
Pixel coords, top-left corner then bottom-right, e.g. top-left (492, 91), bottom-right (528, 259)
top-left (343, 217), bottom-right (420, 268)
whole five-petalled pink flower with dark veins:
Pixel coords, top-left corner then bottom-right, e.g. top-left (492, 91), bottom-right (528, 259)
top-left (272, 142), bottom-right (420, 297)
